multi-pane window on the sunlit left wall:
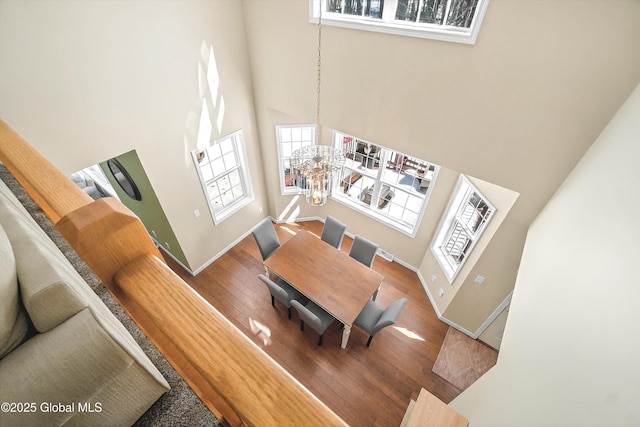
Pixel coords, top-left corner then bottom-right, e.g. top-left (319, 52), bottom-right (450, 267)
top-left (193, 131), bottom-right (253, 224)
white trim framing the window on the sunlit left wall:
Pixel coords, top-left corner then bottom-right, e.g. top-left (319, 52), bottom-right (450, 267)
top-left (191, 129), bottom-right (254, 225)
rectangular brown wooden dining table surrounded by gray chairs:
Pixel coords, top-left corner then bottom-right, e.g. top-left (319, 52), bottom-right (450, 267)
top-left (264, 230), bottom-right (384, 348)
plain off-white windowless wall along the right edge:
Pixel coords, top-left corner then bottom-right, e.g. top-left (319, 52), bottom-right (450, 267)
top-left (451, 86), bottom-right (640, 427)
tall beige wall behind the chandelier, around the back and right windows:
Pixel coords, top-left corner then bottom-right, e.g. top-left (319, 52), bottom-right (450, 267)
top-left (243, 0), bottom-right (640, 333)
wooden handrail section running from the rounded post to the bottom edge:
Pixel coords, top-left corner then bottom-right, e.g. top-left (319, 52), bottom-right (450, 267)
top-left (116, 255), bottom-right (345, 426)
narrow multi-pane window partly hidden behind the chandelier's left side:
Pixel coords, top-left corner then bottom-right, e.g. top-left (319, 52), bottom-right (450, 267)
top-left (276, 125), bottom-right (316, 194)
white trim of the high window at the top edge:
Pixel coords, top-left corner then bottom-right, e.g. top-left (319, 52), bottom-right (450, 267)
top-left (309, 0), bottom-right (489, 45)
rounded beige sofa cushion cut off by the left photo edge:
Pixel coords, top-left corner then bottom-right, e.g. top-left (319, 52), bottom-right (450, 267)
top-left (0, 224), bottom-right (29, 359)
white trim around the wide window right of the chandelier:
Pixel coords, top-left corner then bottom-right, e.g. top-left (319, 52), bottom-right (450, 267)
top-left (330, 130), bottom-right (440, 237)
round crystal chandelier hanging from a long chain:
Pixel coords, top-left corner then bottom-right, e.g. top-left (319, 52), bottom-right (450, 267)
top-left (291, 2), bottom-right (345, 206)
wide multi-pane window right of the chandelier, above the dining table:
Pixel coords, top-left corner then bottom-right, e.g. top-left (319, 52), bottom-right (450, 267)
top-left (332, 132), bottom-right (438, 235)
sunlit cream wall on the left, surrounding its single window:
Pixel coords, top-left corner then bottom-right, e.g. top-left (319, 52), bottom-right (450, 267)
top-left (0, 0), bottom-right (267, 269)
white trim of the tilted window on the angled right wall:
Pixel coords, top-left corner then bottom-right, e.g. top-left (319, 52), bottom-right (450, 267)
top-left (430, 175), bottom-right (496, 283)
